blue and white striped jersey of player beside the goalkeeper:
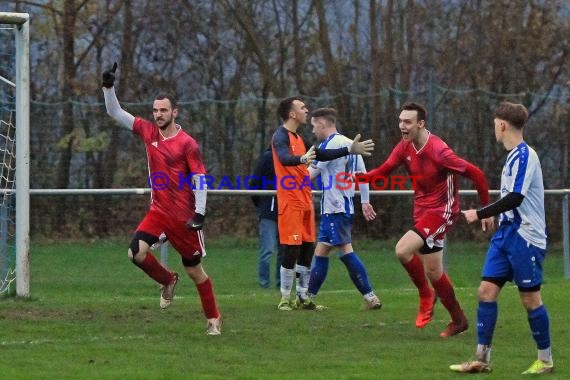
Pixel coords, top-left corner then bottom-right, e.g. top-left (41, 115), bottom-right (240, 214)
top-left (316, 133), bottom-right (369, 215)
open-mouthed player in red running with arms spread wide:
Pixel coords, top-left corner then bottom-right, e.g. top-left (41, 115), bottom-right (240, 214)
top-left (358, 102), bottom-right (493, 338)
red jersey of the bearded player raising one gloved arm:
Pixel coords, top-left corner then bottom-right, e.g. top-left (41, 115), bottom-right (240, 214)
top-left (133, 117), bottom-right (206, 222)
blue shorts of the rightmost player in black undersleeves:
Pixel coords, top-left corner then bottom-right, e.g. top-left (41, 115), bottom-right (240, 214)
top-left (481, 224), bottom-right (546, 288)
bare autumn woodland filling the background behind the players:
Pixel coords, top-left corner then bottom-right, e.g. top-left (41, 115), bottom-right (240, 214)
top-left (0, 0), bottom-right (570, 240)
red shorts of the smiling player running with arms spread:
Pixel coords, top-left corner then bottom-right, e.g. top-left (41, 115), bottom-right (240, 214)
top-left (414, 209), bottom-right (458, 248)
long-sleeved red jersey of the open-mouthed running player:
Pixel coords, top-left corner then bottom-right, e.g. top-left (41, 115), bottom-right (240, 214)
top-left (366, 132), bottom-right (489, 217)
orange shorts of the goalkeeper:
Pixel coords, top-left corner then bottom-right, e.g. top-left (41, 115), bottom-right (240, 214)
top-left (277, 204), bottom-right (316, 245)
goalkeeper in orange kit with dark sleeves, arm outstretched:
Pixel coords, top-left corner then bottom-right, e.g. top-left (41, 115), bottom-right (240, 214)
top-left (271, 96), bottom-right (374, 311)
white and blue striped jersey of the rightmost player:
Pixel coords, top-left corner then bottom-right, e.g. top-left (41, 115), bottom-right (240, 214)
top-left (499, 141), bottom-right (546, 249)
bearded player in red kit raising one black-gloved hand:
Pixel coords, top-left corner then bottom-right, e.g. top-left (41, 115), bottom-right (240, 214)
top-left (102, 63), bottom-right (221, 335)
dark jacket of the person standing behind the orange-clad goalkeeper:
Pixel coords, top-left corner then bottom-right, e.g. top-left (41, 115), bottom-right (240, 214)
top-left (249, 147), bottom-right (277, 220)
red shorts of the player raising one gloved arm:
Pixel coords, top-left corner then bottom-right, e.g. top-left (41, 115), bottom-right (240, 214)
top-left (137, 210), bottom-right (206, 260)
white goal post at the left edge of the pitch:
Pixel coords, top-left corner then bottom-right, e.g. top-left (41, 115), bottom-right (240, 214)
top-left (0, 12), bottom-right (30, 297)
